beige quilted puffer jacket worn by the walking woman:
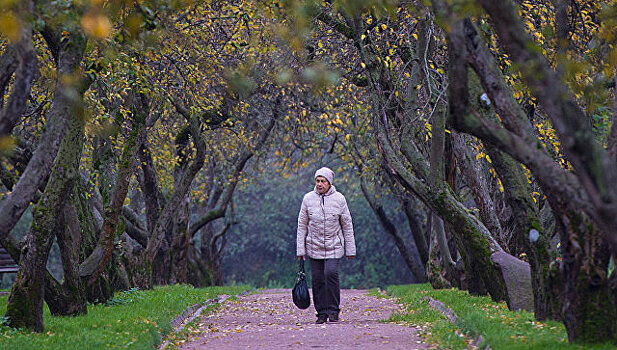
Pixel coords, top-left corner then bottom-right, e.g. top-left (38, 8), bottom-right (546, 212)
top-left (296, 186), bottom-right (356, 259)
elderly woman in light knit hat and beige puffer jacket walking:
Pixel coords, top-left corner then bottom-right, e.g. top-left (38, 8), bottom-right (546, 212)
top-left (296, 167), bottom-right (356, 324)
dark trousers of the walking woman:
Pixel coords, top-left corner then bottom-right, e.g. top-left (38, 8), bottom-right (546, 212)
top-left (310, 258), bottom-right (341, 315)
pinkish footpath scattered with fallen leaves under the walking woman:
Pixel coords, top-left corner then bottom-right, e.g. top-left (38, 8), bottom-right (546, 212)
top-left (180, 289), bottom-right (430, 349)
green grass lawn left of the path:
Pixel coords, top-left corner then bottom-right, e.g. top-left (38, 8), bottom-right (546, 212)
top-left (0, 285), bottom-right (250, 350)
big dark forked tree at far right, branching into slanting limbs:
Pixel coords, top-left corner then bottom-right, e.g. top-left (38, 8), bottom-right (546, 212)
top-left (435, 0), bottom-right (617, 343)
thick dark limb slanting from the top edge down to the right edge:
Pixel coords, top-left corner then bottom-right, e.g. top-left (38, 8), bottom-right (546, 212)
top-left (478, 0), bottom-right (617, 255)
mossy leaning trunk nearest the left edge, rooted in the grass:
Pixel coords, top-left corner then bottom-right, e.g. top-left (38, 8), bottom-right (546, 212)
top-left (5, 30), bottom-right (86, 332)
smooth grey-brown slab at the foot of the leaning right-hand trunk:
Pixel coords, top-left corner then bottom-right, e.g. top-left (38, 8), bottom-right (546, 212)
top-left (491, 252), bottom-right (533, 312)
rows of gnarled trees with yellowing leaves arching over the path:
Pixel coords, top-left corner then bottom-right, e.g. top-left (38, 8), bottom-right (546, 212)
top-left (0, 0), bottom-right (617, 342)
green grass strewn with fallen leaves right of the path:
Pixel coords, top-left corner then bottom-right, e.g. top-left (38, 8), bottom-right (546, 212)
top-left (388, 284), bottom-right (615, 350)
